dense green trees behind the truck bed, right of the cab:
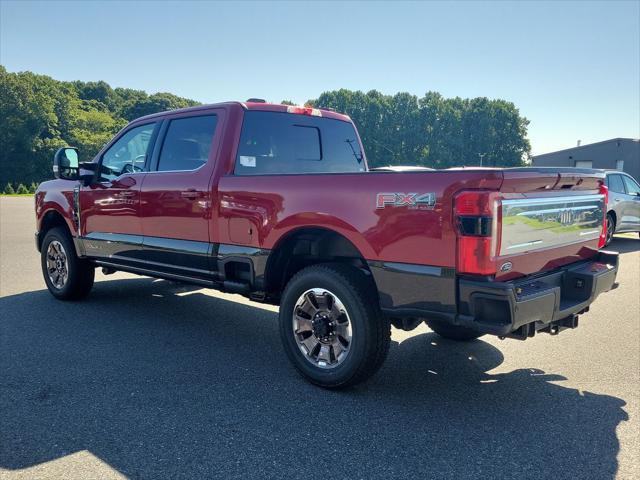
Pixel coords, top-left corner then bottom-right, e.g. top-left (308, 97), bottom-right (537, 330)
top-left (308, 89), bottom-right (531, 168)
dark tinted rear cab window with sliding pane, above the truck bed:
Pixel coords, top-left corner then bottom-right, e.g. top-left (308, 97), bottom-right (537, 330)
top-left (235, 111), bottom-right (364, 175)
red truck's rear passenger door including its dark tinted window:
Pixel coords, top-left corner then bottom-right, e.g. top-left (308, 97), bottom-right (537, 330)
top-left (141, 109), bottom-right (224, 277)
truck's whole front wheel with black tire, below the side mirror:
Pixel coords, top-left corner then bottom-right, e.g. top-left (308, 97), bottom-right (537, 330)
top-left (40, 228), bottom-right (95, 300)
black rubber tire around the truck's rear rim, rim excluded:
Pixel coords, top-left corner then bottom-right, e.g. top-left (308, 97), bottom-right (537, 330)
top-left (279, 269), bottom-right (371, 386)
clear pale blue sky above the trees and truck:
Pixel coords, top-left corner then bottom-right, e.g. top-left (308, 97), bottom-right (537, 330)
top-left (0, 0), bottom-right (640, 154)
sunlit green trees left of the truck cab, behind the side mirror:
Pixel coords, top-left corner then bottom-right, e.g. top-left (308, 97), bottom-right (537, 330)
top-left (0, 66), bottom-right (196, 184)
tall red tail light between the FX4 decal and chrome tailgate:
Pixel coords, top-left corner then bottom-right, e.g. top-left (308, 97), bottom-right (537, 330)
top-left (454, 190), bottom-right (500, 275)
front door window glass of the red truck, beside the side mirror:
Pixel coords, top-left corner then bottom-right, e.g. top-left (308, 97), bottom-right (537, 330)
top-left (100, 123), bottom-right (156, 182)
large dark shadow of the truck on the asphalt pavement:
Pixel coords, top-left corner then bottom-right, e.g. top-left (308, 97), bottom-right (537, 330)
top-left (0, 278), bottom-right (627, 479)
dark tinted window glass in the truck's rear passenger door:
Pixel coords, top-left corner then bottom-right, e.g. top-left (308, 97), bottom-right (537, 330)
top-left (158, 115), bottom-right (218, 172)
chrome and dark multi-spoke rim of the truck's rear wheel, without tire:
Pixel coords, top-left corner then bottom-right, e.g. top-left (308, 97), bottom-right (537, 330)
top-left (293, 288), bottom-right (351, 369)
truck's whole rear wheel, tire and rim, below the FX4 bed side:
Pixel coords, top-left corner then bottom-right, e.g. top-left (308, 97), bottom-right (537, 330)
top-left (279, 264), bottom-right (391, 388)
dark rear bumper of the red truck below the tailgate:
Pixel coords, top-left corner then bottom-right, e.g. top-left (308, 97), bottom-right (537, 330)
top-left (453, 251), bottom-right (618, 338)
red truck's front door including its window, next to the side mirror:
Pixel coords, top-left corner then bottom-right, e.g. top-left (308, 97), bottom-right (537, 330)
top-left (79, 122), bottom-right (159, 261)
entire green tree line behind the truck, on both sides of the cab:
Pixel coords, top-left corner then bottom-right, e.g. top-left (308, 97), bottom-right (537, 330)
top-left (0, 65), bottom-right (530, 189)
